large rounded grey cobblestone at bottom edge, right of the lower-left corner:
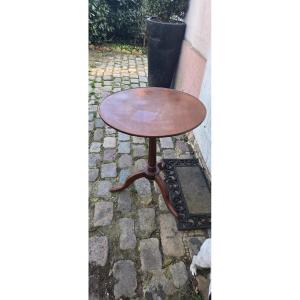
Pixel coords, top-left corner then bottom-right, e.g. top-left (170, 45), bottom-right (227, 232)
top-left (113, 260), bottom-right (137, 299)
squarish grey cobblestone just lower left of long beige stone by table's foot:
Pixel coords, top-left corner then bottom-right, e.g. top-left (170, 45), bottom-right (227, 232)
top-left (140, 238), bottom-right (162, 272)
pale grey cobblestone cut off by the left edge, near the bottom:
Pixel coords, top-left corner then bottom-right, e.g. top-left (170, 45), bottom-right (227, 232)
top-left (89, 236), bottom-right (108, 267)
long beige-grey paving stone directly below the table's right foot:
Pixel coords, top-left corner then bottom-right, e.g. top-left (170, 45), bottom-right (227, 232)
top-left (159, 214), bottom-right (184, 257)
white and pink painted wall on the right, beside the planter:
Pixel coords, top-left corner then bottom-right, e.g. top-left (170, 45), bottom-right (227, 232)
top-left (175, 0), bottom-right (211, 176)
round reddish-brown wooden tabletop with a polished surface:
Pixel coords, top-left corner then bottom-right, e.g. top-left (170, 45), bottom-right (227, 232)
top-left (99, 87), bottom-right (206, 137)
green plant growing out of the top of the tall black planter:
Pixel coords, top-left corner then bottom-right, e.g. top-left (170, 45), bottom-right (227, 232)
top-left (145, 0), bottom-right (189, 22)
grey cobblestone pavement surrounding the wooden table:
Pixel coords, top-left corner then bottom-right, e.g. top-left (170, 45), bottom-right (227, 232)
top-left (89, 51), bottom-right (211, 300)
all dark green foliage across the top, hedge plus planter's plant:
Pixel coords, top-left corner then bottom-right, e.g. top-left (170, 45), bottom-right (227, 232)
top-left (89, 0), bottom-right (188, 44)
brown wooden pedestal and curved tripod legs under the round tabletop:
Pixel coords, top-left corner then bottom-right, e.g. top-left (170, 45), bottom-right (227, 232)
top-left (110, 138), bottom-right (178, 218)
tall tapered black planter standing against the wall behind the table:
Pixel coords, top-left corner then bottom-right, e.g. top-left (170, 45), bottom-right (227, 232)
top-left (147, 17), bottom-right (186, 88)
